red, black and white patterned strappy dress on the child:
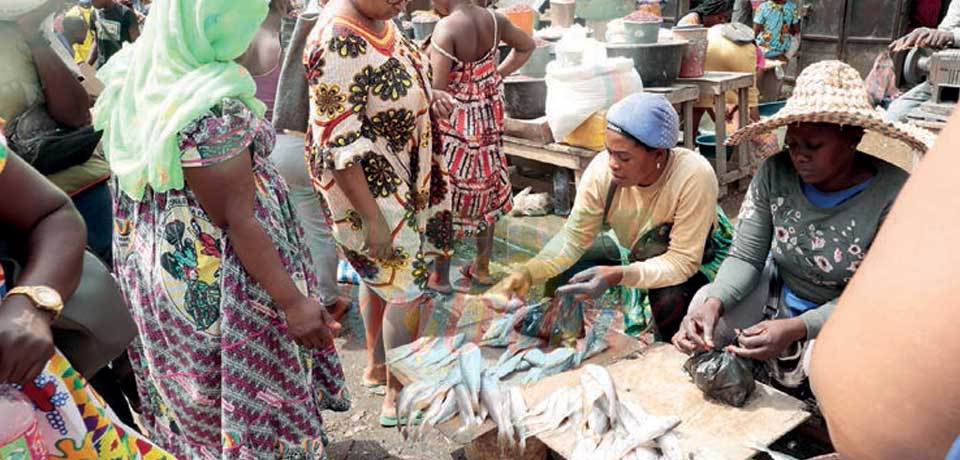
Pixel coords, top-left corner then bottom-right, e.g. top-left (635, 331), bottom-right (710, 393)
top-left (434, 18), bottom-right (513, 237)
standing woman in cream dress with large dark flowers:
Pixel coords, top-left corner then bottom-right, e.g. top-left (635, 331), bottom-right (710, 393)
top-left (304, 0), bottom-right (453, 426)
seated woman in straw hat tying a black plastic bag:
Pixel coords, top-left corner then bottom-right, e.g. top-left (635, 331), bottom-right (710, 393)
top-left (673, 61), bottom-right (931, 387)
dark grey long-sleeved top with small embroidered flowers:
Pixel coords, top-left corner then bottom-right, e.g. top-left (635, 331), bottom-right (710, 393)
top-left (709, 152), bottom-right (908, 338)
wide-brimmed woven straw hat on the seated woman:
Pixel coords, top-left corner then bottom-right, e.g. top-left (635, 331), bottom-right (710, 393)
top-left (727, 61), bottom-right (935, 152)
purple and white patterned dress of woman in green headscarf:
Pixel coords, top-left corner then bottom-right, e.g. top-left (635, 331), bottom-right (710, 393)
top-left (114, 99), bottom-right (349, 459)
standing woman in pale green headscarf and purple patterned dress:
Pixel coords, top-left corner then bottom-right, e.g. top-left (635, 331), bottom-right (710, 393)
top-left (95, 0), bottom-right (349, 459)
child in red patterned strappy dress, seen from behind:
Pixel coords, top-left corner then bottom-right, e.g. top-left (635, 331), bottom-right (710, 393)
top-left (429, 0), bottom-right (536, 293)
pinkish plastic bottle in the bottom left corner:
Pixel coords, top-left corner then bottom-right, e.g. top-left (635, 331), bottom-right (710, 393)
top-left (0, 384), bottom-right (49, 460)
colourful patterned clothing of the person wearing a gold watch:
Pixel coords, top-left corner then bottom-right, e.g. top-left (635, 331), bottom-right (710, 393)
top-left (0, 135), bottom-right (174, 460)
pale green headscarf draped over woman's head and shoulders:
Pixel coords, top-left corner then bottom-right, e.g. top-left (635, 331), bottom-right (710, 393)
top-left (93, 0), bottom-right (269, 200)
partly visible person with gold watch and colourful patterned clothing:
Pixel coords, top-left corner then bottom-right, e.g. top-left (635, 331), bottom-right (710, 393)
top-left (0, 134), bottom-right (173, 460)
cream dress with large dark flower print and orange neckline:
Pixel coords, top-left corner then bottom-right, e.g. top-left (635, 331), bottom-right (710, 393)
top-left (304, 17), bottom-right (453, 303)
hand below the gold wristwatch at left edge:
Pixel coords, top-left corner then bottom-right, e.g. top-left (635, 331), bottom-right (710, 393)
top-left (0, 295), bottom-right (54, 385)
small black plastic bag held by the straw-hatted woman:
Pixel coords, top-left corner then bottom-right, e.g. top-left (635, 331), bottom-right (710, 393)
top-left (683, 350), bottom-right (757, 407)
